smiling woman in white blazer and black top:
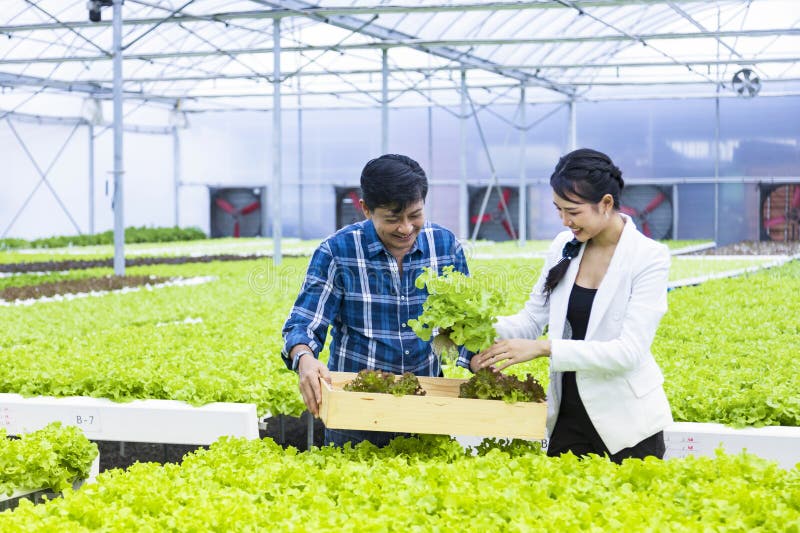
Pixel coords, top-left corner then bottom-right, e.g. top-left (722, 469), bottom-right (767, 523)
top-left (470, 148), bottom-right (672, 462)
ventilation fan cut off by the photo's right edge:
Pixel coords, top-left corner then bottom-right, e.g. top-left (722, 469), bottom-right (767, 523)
top-left (761, 183), bottom-right (800, 242)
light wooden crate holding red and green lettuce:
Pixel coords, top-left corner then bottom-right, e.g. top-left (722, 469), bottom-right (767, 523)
top-left (320, 372), bottom-right (547, 439)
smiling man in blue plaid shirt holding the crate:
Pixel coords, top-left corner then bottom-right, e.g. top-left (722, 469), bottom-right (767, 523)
top-left (282, 154), bottom-right (469, 446)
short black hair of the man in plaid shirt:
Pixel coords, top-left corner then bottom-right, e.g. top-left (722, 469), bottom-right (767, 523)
top-left (361, 154), bottom-right (428, 213)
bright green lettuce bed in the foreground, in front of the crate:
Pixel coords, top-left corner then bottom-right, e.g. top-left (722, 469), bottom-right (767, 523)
top-left (0, 436), bottom-right (800, 533)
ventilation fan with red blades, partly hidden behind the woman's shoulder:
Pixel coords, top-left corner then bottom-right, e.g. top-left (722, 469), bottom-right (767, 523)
top-left (619, 185), bottom-right (672, 240)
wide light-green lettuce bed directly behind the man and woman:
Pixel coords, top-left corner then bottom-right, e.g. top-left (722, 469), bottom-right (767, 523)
top-left (0, 251), bottom-right (800, 426)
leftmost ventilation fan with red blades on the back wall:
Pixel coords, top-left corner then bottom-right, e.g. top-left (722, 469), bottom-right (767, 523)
top-left (209, 187), bottom-right (261, 237)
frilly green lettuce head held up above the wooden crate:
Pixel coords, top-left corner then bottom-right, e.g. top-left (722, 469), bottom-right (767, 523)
top-left (408, 266), bottom-right (502, 352)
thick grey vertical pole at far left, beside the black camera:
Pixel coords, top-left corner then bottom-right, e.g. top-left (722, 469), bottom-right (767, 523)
top-left (113, 0), bottom-right (125, 276)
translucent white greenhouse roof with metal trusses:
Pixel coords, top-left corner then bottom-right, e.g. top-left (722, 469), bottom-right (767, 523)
top-left (0, 0), bottom-right (800, 117)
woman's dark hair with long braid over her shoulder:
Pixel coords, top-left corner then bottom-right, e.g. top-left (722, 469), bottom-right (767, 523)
top-left (544, 148), bottom-right (625, 299)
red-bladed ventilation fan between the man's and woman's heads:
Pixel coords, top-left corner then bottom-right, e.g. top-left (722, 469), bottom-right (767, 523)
top-left (469, 187), bottom-right (519, 241)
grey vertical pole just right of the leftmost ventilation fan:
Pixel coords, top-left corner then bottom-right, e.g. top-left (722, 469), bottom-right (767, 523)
top-left (272, 18), bottom-right (282, 265)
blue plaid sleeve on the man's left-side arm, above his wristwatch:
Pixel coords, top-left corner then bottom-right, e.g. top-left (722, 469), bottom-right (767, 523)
top-left (281, 243), bottom-right (342, 369)
